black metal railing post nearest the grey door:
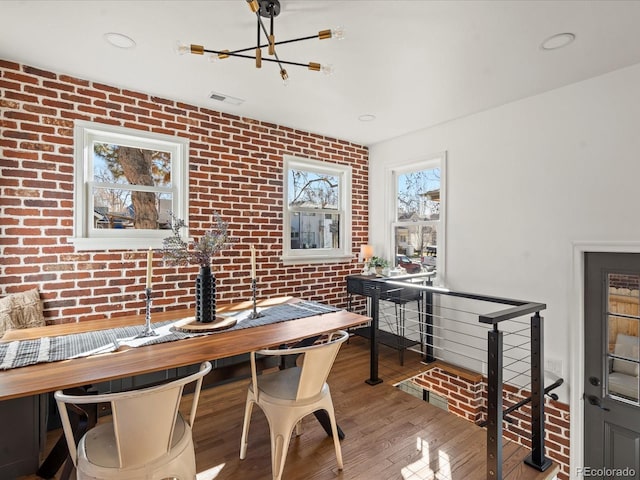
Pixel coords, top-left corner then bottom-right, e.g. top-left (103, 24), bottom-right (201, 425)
top-left (524, 312), bottom-right (552, 472)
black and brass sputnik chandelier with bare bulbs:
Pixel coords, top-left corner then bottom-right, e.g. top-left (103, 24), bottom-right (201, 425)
top-left (178, 0), bottom-right (344, 85)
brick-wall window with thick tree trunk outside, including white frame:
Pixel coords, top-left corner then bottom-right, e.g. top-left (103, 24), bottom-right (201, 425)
top-left (71, 121), bottom-right (189, 250)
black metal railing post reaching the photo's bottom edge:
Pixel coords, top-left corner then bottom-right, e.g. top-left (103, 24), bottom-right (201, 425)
top-left (487, 324), bottom-right (502, 480)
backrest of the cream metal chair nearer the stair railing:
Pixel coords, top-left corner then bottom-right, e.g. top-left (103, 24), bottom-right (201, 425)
top-left (254, 330), bottom-right (349, 400)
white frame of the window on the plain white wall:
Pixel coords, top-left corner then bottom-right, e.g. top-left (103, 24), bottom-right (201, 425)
top-left (389, 152), bottom-right (447, 285)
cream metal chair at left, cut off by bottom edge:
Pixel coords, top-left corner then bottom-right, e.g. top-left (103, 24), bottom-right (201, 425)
top-left (54, 362), bottom-right (211, 480)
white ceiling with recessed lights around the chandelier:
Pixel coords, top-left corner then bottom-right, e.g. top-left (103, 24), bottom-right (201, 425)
top-left (0, 0), bottom-right (640, 145)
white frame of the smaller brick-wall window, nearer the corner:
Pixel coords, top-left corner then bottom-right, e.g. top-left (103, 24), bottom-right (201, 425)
top-left (282, 155), bottom-right (353, 265)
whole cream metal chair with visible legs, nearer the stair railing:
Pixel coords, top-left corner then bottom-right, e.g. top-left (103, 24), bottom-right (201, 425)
top-left (240, 330), bottom-right (349, 480)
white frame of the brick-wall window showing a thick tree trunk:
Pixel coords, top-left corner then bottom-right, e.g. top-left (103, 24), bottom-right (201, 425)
top-left (69, 120), bottom-right (189, 251)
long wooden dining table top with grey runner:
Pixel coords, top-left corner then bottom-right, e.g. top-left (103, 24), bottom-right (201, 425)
top-left (0, 297), bottom-right (370, 401)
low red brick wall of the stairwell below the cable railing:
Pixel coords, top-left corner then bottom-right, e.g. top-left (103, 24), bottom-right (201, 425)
top-left (412, 367), bottom-right (570, 480)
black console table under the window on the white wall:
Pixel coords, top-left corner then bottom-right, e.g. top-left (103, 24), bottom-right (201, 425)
top-left (346, 274), bottom-right (435, 365)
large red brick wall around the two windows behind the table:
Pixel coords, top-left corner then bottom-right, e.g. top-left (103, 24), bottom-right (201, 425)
top-left (0, 60), bottom-right (368, 322)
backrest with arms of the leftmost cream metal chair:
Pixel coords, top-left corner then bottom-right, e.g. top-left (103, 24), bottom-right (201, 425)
top-left (55, 362), bottom-right (211, 468)
